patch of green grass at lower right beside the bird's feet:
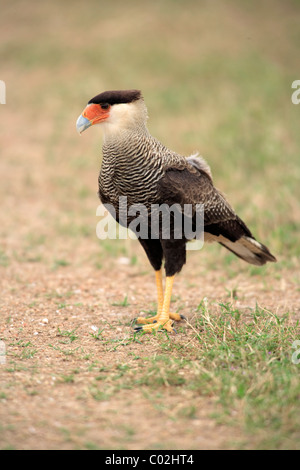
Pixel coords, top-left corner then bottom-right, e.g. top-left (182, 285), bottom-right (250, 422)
top-left (86, 302), bottom-right (300, 449)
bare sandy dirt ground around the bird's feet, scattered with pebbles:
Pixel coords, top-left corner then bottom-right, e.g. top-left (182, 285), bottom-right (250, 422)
top-left (0, 246), bottom-right (300, 449)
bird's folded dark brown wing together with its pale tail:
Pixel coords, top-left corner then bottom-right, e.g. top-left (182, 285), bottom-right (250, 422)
top-left (158, 165), bottom-right (275, 265)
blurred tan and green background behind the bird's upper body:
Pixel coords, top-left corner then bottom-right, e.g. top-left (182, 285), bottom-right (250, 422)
top-left (0, 0), bottom-right (300, 270)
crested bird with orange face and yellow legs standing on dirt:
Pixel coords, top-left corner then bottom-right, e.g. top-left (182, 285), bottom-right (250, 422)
top-left (76, 89), bottom-right (276, 333)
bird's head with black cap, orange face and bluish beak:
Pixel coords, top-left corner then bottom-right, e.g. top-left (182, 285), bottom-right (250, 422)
top-left (76, 90), bottom-right (147, 134)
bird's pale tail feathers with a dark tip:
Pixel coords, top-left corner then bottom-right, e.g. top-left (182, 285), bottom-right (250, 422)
top-left (218, 235), bottom-right (276, 266)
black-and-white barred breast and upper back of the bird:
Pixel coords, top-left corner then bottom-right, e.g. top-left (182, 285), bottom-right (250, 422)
top-left (99, 126), bottom-right (186, 208)
